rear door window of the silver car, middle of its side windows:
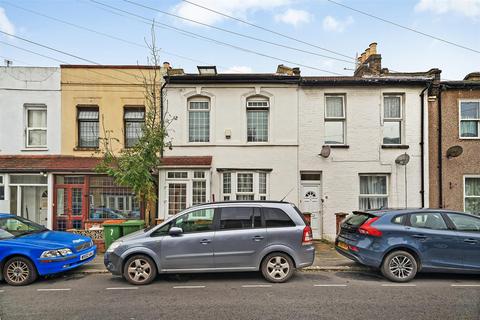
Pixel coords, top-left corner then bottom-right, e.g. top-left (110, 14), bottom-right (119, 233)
top-left (220, 207), bottom-right (261, 230)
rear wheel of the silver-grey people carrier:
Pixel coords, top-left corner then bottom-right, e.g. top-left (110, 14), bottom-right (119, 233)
top-left (261, 252), bottom-right (295, 283)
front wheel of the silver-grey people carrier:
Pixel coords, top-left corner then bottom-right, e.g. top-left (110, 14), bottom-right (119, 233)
top-left (123, 255), bottom-right (157, 285)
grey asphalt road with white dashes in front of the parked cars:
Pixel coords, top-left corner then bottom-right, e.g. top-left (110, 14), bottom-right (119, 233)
top-left (0, 271), bottom-right (480, 320)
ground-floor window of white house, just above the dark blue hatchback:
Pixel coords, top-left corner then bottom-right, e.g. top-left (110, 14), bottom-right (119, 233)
top-left (359, 174), bottom-right (388, 210)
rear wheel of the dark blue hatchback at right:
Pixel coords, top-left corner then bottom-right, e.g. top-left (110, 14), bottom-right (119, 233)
top-left (382, 251), bottom-right (418, 282)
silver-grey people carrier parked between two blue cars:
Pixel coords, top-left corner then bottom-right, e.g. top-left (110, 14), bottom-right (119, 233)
top-left (104, 201), bottom-right (315, 285)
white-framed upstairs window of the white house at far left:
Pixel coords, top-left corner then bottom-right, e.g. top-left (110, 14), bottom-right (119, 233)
top-left (25, 106), bottom-right (47, 148)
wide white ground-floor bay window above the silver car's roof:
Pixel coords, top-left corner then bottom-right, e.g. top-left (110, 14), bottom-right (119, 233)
top-left (221, 171), bottom-right (268, 201)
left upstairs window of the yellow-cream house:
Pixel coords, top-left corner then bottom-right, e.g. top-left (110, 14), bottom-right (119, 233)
top-left (77, 106), bottom-right (99, 148)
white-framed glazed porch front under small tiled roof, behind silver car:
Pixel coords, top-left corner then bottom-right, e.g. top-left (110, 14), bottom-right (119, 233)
top-left (165, 169), bottom-right (210, 215)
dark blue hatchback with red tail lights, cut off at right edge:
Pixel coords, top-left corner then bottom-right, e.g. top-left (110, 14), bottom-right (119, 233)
top-left (335, 209), bottom-right (480, 282)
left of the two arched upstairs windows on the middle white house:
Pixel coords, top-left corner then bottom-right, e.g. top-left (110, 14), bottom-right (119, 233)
top-left (188, 98), bottom-right (210, 142)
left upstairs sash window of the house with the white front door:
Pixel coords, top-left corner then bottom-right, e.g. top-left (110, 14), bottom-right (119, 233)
top-left (325, 95), bottom-right (345, 144)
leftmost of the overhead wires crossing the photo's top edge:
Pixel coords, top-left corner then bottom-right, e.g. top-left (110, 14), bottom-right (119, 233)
top-left (90, 0), bottom-right (342, 75)
